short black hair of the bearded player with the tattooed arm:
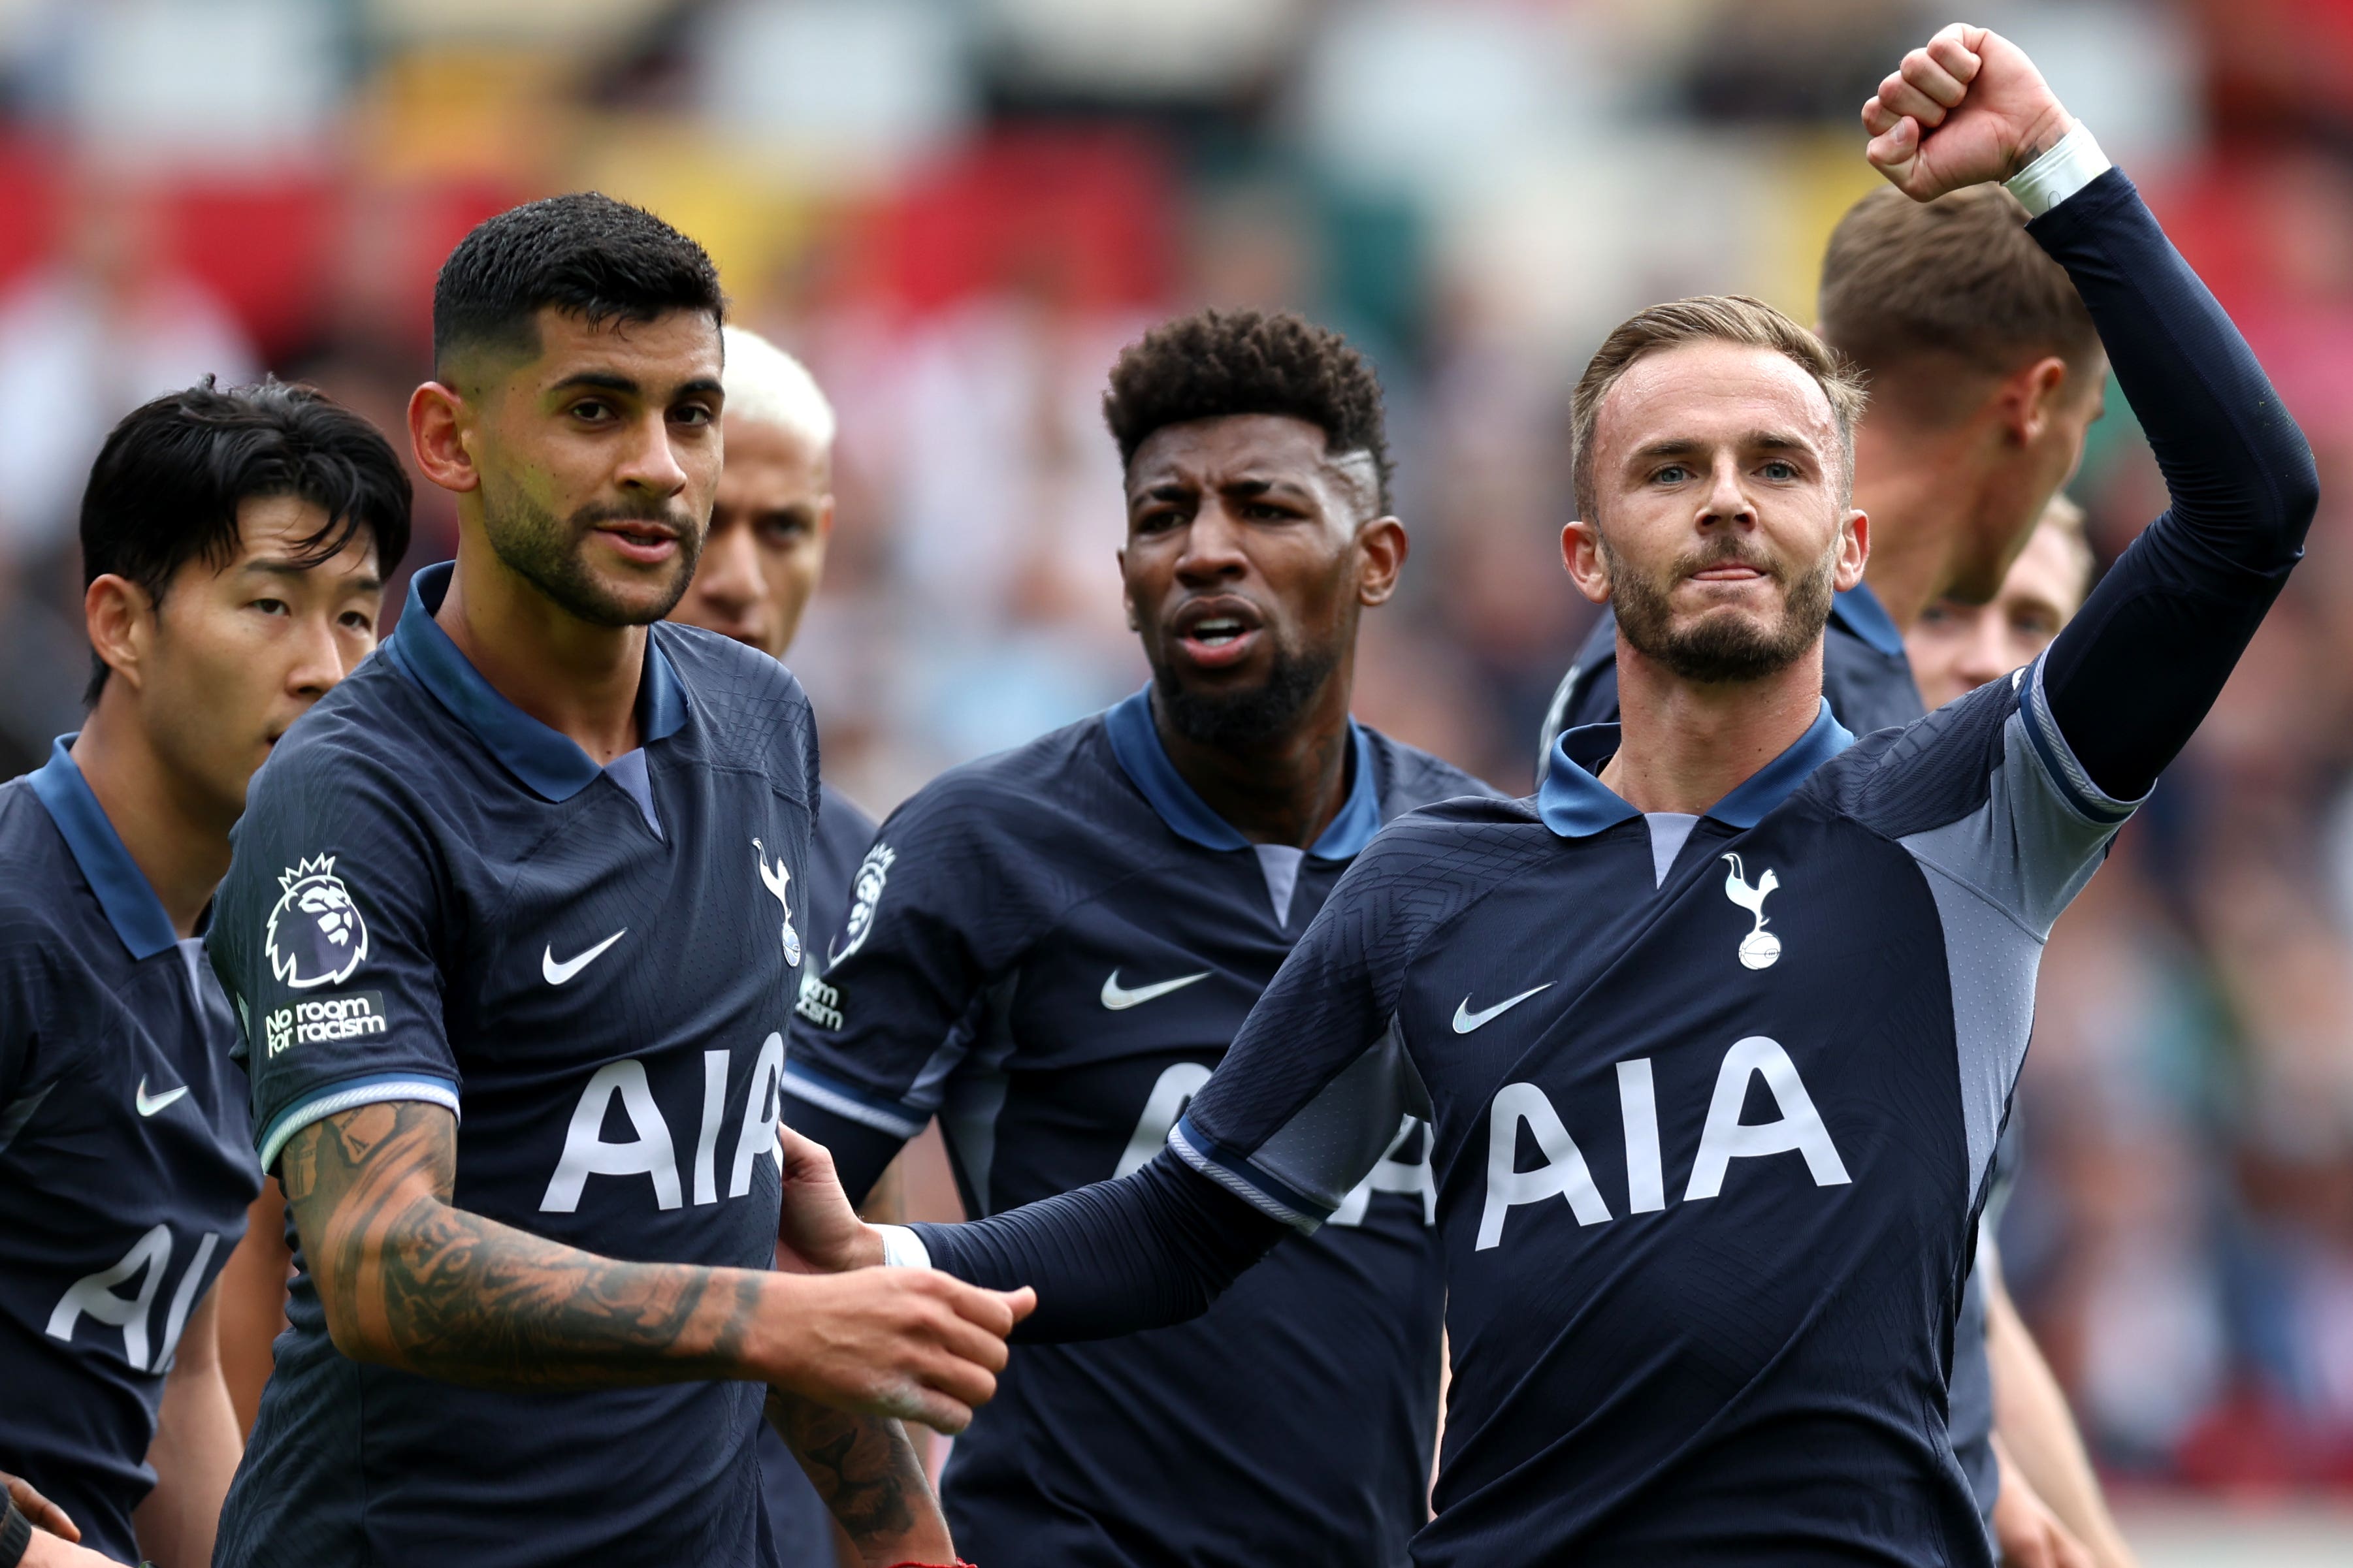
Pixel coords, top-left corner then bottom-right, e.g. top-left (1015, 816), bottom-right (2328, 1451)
top-left (433, 191), bottom-right (727, 374)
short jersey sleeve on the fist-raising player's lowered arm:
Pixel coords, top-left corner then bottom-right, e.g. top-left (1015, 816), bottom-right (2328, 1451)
top-left (1169, 813), bottom-right (1485, 1230)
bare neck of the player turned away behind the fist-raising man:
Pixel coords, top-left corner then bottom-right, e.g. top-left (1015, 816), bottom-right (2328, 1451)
top-left (1854, 421), bottom-right (1986, 632)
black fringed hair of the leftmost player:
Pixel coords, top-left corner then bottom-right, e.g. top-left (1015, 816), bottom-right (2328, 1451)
top-left (82, 376), bottom-right (410, 703)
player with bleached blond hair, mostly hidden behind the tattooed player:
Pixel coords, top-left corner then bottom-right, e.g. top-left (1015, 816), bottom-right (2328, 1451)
top-left (671, 327), bottom-right (896, 1563)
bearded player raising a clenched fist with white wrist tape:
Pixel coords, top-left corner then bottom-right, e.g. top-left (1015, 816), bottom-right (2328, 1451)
top-left (788, 26), bottom-right (2318, 1565)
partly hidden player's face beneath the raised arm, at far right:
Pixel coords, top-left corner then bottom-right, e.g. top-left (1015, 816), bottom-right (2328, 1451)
top-left (1904, 496), bottom-right (2094, 708)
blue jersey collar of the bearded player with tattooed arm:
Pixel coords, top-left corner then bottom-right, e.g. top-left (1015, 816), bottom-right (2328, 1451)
top-left (383, 562), bottom-right (687, 801)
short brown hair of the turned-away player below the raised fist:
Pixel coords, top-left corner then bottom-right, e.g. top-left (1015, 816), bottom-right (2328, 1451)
top-left (1819, 185), bottom-right (2101, 407)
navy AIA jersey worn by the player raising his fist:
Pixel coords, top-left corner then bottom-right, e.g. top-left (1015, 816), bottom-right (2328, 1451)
top-left (1174, 665), bottom-right (2132, 1565)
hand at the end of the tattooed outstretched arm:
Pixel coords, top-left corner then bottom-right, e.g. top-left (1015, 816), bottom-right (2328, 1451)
top-left (758, 1270), bottom-right (1037, 1436)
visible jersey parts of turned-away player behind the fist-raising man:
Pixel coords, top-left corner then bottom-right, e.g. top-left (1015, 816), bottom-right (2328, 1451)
top-left (1536, 583), bottom-right (2014, 1518)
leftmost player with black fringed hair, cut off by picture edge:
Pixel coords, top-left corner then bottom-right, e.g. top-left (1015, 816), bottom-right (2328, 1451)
top-left (0, 381), bottom-right (410, 1568)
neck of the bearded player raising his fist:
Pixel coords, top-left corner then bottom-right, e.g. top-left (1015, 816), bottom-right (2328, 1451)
top-left (1600, 632), bottom-right (1821, 816)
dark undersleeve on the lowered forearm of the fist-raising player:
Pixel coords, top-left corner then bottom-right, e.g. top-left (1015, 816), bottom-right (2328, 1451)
top-left (913, 1149), bottom-right (1291, 1340)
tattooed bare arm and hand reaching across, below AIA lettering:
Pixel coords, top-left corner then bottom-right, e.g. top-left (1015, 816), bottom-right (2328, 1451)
top-left (280, 1100), bottom-right (1019, 1432)
